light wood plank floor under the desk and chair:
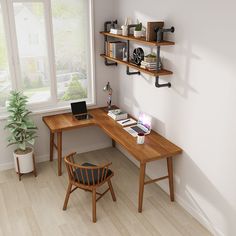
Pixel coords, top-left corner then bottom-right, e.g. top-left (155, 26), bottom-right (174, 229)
top-left (0, 148), bottom-right (211, 236)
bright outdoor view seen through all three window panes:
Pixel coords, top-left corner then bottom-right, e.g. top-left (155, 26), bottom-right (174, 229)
top-left (0, 0), bottom-right (89, 107)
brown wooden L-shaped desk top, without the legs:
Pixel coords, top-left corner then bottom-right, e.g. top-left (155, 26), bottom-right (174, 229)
top-left (43, 108), bottom-right (182, 162)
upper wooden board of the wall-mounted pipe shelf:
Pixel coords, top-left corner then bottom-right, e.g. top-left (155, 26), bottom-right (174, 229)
top-left (100, 32), bottom-right (175, 46)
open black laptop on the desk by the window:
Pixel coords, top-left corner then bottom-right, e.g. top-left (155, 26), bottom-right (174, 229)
top-left (70, 101), bottom-right (93, 120)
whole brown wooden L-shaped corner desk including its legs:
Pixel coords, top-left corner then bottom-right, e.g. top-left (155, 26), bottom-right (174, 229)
top-left (43, 108), bottom-right (182, 212)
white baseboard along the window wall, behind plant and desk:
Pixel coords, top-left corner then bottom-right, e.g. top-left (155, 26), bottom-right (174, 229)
top-left (0, 142), bottom-right (111, 171)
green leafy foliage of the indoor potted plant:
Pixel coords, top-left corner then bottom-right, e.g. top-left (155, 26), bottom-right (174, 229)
top-left (5, 91), bottom-right (37, 152)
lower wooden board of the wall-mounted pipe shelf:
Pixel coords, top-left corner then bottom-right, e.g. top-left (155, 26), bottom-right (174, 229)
top-left (100, 54), bottom-right (173, 77)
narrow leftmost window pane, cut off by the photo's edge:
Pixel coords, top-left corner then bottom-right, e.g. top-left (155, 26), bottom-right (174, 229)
top-left (0, 5), bottom-right (11, 107)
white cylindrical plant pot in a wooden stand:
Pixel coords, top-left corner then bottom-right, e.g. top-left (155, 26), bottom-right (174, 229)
top-left (13, 148), bottom-right (34, 174)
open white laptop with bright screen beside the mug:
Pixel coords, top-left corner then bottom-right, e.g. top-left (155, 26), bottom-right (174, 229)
top-left (124, 112), bottom-right (152, 137)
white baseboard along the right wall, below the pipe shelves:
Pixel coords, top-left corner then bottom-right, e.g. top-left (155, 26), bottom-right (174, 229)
top-left (116, 144), bottom-right (225, 236)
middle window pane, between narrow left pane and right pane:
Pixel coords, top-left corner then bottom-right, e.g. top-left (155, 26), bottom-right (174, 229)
top-left (14, 2), bottom-right (50, 103)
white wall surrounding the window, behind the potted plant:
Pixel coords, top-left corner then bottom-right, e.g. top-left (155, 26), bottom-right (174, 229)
top-left (0, 0), bottom-right (117, 170)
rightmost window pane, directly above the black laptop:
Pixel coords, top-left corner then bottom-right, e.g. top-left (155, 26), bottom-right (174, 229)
top-left (52, 0), bottom-right (91, 101)
